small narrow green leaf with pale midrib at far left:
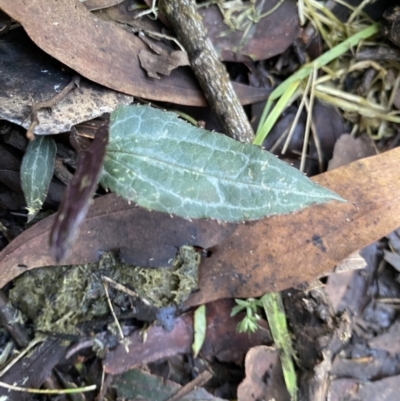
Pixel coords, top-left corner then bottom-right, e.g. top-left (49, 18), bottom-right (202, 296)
top-left (21, 135), bottom-right (57, 222)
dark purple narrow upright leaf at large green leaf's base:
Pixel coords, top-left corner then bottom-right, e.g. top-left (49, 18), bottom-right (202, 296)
top-left (50, 126), bottom-right (108, 262)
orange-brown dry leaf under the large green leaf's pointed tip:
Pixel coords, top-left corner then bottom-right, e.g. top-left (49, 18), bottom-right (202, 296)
top-left (187, 148), bottom-right (400, 305)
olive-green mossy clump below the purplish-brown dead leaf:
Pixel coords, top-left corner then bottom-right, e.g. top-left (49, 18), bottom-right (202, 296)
top-left (9, 246), bottom-right (200, 333)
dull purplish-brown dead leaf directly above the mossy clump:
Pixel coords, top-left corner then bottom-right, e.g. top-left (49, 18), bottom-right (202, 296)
top-left (0, 194), bottom-right (236, 287)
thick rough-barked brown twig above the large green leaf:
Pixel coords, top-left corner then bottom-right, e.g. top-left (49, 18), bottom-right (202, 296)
top-left (159, 0), bottom-right (254, 142)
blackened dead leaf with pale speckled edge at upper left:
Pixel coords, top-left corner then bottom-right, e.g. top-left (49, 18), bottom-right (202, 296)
top-left (0, 29), bottom-right (133, 135)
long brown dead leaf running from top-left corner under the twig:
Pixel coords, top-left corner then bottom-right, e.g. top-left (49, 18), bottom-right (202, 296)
top-left (0, 0), bottom-right (269, 106)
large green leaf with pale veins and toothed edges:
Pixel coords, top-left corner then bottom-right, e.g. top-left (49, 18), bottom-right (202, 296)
top-left (101, 106), bottom-right (343, 222)
